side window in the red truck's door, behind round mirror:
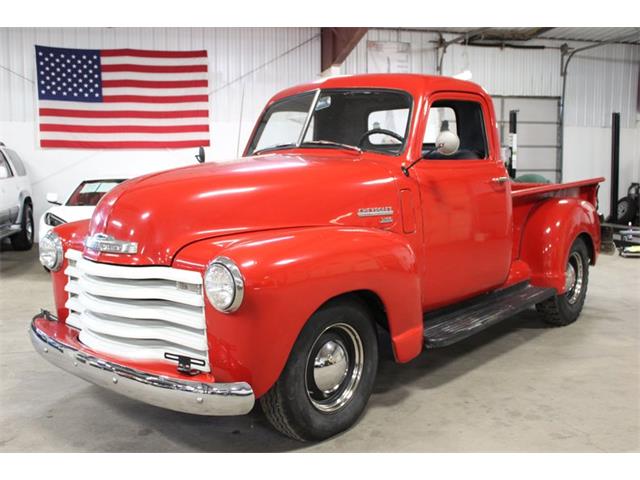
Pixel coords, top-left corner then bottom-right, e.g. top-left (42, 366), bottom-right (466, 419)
top-left (422, 100), bottom-right (488, 160)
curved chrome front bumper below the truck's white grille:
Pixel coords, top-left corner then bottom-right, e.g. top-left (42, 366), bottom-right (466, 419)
top-left (29, 311), bottom-right (255, 415)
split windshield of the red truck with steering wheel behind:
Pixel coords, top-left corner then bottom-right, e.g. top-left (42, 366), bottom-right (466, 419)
top-left (249, 89), bottom-right (411, 155)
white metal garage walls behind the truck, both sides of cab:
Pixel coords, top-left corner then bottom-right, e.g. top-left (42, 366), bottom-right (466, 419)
top-left (0, 28), bottom-right (640, 236)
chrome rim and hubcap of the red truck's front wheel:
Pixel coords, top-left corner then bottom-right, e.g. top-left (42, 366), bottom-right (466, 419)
top-left (305, 323), bottom-right (364, 413)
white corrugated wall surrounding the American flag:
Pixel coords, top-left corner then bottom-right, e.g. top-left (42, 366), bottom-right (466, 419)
top-left (0, 28), bottom-right (320, 237)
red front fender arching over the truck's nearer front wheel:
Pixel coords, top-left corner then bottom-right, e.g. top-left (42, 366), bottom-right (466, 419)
top-left (174, 227), bottom-right (422, 396)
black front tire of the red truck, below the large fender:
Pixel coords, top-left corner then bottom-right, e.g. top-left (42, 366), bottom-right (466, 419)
top-left (260, 300), bottom-right (378, 441)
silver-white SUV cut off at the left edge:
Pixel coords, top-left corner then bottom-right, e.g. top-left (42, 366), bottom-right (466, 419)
top-left (0, 142), bottom-right (34, 250)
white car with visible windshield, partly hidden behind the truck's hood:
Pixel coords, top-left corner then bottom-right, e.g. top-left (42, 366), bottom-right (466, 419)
top-left (38, 178), bottom-right (124, 241)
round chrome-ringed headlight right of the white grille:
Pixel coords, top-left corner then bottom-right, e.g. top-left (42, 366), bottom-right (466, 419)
top-left (204, 257), bottom-right (244, 313)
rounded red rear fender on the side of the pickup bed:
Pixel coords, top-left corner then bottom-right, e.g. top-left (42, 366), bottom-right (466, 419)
top-left (520, 198), bottom-right (600, 293)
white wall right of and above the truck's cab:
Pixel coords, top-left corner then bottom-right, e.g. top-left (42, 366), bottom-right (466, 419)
top-left (340, 29), bottom-right (640, 214)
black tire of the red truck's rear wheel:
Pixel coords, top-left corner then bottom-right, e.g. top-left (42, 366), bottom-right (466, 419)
top-left (536, 238), bottom-right (589, 327)
